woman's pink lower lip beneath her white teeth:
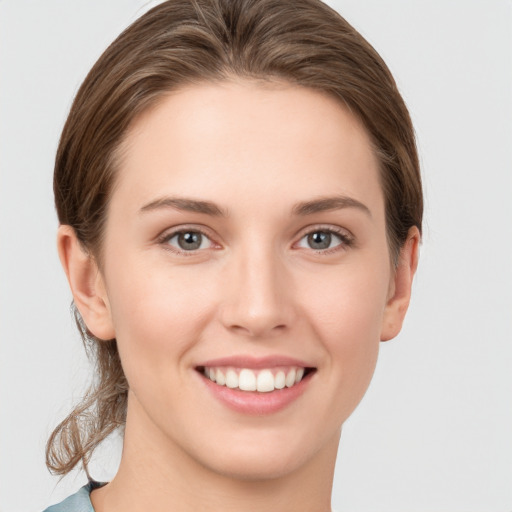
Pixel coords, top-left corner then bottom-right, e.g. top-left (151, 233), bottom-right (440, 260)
top-left (200, 374), bottom-right (312, 415)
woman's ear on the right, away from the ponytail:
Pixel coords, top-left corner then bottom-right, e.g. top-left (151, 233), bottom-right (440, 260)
top-left (380, 226), bottom-right (421, 341)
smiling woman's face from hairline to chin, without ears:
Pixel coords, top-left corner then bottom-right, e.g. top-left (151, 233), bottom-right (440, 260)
top-left (84, 81), bottom-right (410, 478)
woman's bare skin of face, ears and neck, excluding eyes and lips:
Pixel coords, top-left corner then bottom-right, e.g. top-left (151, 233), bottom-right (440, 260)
top-left (58, 80), bottom-right (419, 512)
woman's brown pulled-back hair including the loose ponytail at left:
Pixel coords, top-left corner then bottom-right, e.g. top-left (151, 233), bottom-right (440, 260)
top-left (46, 0), bottom-right (423, 474)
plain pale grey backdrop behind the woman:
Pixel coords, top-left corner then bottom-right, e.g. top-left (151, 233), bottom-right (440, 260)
top-left (0, 0), bottom-right (512, 512)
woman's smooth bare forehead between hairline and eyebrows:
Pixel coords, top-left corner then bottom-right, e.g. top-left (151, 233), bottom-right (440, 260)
top-left (113, 80), bottom-right (382, 218)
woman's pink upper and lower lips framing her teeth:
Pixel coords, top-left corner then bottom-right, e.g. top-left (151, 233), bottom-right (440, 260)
top-left (196, 356), bottom-right (316, 416)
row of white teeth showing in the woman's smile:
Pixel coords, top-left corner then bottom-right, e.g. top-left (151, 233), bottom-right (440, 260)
top-left (203, 367), bottom-right (304, 393)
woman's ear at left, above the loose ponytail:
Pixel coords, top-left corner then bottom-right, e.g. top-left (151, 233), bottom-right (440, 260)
top-left (57, 225), bottom-right (115, 340)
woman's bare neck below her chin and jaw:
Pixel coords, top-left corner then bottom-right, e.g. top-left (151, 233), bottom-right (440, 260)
top-left (91, 394), bottom-right (339, 512)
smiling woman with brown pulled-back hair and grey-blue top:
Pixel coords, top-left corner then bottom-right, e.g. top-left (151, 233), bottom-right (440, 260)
top-left (47, 0), bottom-right (422, 512)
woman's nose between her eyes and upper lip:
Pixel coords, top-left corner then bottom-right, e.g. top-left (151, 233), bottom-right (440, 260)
top-left (220, 245), bottom-right (295, 338)
